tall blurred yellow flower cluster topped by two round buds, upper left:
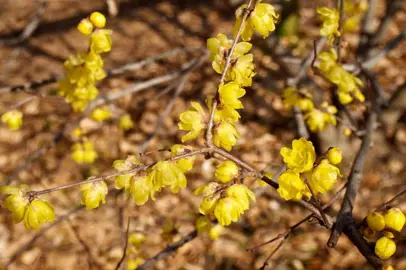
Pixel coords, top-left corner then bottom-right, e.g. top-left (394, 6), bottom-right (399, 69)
top-left (59, 12), bottom-right (112, 111)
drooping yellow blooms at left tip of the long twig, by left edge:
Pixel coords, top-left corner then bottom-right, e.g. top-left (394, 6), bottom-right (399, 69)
top-left (0, 185), bottom-right (55, 230)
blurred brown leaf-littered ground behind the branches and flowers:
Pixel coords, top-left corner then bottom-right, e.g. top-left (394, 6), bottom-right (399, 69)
top-left (0, 0), bottom-right (406, 270)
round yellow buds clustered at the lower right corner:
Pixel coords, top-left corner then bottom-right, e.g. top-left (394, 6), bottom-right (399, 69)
top-left (363, 208), bottom-right (406, 260)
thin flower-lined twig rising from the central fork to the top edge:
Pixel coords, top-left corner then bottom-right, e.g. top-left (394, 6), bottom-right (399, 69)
top-left (206, 0), bottom-right (257, 146)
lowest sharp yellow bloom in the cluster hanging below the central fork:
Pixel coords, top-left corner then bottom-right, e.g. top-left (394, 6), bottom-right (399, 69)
top-left (214, 197), bottom-right (244, 226)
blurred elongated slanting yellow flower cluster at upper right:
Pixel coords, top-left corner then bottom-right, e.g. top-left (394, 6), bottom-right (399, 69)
top-left (318, 48), bottom-right (365, 105)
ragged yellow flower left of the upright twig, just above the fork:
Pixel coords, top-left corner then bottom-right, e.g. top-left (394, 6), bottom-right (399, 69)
top-left (178, 101), bottom-right (205, 142)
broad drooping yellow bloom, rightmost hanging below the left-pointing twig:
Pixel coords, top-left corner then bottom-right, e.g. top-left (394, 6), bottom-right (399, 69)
top-left (148, 161), bottom-right (187, 193)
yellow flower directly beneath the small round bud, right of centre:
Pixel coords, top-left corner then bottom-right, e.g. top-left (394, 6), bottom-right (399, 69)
top-left (308, 159), bottom-right (341, 194)
